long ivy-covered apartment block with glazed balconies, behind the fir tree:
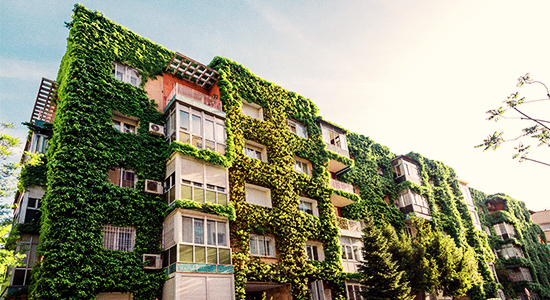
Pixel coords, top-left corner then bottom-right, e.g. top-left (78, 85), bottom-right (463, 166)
top-left (6, 5), bottom-right (550, 300)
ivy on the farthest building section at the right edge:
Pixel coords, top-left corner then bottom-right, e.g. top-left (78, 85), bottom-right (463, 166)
top-left (471, 189), bottom-right (550, 299)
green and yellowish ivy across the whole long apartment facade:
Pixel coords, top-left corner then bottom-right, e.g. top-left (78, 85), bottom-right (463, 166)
top-left (11, 5), bottom-right (550, 300)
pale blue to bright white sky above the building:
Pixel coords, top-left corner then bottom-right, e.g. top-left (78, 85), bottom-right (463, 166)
top-left (0, 0), bottom-right (550, 211)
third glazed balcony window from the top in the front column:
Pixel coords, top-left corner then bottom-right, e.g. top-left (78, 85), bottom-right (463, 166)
top-left (178, 216), bottom-right (231, 265)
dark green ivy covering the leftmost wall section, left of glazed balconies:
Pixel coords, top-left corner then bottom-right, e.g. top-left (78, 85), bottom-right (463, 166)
top-left (30, 5), bottom-right (172, 299)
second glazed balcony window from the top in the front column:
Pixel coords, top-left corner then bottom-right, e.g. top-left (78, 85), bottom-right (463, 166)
top-left (180, 158), bottom-right (229, 205)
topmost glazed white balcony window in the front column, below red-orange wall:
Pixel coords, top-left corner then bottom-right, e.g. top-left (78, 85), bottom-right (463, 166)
top-left (166, 104), bottom-right (226, 155)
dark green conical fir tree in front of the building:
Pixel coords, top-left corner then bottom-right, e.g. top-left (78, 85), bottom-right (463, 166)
top-left (359, 216), bottom-right (413, 300)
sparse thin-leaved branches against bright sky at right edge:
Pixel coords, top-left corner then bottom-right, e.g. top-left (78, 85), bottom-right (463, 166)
top-left (475, 73), bottom-right (550, 166)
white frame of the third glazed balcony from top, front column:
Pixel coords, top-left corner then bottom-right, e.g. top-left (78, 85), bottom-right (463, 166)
top-left (180, 215), bottom-right (232, 265)
